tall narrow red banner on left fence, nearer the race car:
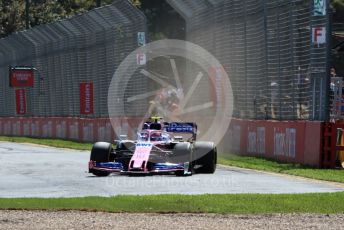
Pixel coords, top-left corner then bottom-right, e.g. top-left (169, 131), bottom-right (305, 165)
top-left (80, 82), bottom-right (93, 114)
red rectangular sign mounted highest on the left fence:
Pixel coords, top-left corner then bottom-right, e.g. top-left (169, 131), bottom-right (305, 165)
top-left (10, 69), bottom-right (34, 88)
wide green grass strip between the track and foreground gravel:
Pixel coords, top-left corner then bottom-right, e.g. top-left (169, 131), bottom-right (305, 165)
top-left (0, 192), bottom-right (344, 214)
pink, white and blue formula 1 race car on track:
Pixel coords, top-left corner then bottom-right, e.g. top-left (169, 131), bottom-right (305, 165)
top-left (89, 118), bottom-right (217, 176)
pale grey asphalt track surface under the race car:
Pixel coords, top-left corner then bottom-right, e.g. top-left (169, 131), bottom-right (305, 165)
top-left (0, 142), bottom-right (344, 197)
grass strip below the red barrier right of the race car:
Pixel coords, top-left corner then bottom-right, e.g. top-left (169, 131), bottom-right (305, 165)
top-left (219, 154), bottom-right (344, 183)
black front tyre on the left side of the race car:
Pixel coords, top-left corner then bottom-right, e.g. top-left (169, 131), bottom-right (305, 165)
top-left (90, 142), bottom-right (113, 176)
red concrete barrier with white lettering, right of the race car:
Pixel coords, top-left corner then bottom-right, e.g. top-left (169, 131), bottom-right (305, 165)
top-left (221, 119), bottom-right (322, 167)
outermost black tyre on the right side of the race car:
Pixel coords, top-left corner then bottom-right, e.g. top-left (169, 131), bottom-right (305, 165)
top-left (194, 142), bottom-right (217, 174)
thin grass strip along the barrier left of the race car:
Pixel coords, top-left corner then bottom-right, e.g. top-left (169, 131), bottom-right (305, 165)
top-left (0, 136), bottom-right (92, 150)
